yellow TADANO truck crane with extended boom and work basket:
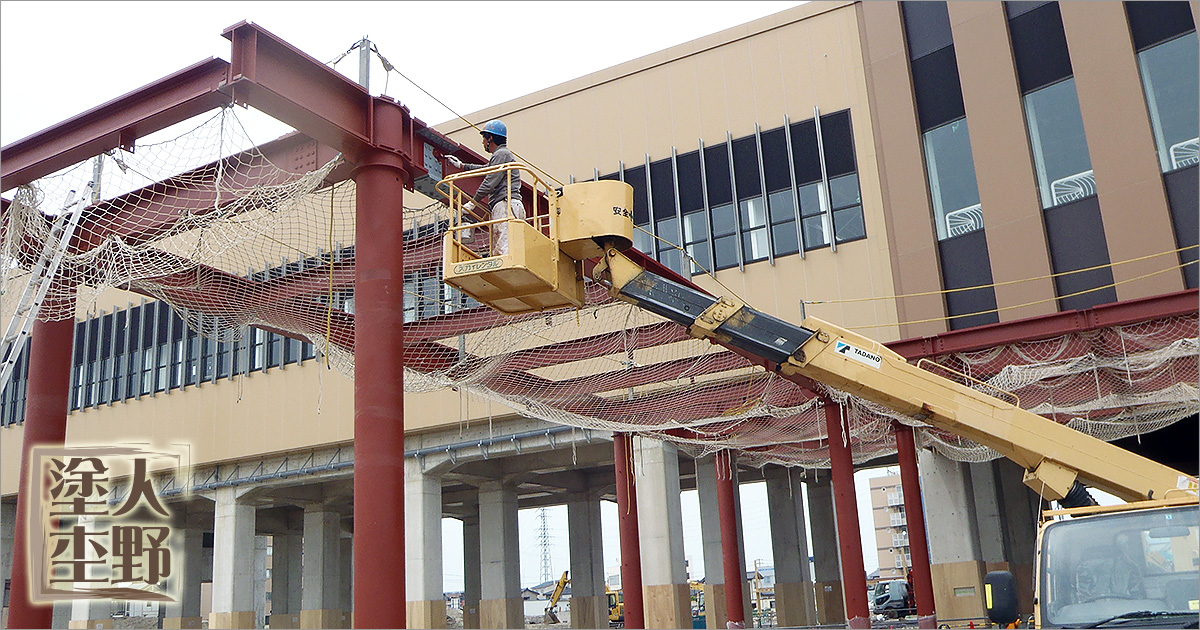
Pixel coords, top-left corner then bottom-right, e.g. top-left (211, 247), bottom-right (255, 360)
top-left (438, 162), bottom-right (1200, 628)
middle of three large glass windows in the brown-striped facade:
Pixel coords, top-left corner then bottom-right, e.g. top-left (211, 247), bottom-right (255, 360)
top-left (1025, 77), bottom-right (1096, 208)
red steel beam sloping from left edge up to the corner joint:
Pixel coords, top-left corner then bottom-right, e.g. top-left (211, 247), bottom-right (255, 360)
top-left (0, 58), bottom-right (229, 191)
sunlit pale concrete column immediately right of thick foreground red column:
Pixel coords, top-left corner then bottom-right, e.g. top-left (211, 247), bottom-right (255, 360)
top-left (404, 457), bottom-right (446, 628)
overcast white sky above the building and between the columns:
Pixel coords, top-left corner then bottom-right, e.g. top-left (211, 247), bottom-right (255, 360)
top-left (0, 0), bottom-right (907, 589)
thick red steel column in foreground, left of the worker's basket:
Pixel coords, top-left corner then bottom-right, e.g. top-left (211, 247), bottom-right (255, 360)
top-left (354, 106), bottom-right (408, 628)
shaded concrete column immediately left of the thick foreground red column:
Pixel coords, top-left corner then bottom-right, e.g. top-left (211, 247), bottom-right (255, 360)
top-left (300, 506), bottom-right (342, 628)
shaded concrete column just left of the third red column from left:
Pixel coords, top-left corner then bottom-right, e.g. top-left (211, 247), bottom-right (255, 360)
top-left (566, 492), bottom-right (608, 628)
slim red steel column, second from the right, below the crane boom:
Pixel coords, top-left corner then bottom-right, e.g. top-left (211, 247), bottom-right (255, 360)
top-left (824, 398), bottom-right (871, 628)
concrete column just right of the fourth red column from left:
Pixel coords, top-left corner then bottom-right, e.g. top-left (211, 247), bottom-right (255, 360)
top-left (763, 466), bottom-right (817, 626)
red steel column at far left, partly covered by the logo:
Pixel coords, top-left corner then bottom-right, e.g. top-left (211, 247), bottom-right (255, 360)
top-left (8, 292), bottom-right (74, 628)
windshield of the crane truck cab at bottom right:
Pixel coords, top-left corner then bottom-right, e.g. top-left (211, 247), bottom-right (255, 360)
top-left (1039, 506), bottom-right (1200, 626)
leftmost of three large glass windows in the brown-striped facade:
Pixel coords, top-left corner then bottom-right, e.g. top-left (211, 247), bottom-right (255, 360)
top-left (924, 118), bottom-right (983, 240)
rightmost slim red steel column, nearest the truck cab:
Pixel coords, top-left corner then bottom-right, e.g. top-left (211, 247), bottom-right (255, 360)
top-left (892, 420), bottom-right (937, 628)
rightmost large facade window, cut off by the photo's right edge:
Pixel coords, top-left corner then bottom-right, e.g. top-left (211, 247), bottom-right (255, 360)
top-left (1138, 31), bottom-right (1200, 173)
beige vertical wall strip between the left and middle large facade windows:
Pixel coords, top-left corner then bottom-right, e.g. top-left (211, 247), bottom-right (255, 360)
top-left (948, 1), bottom-right (1058, 322)
